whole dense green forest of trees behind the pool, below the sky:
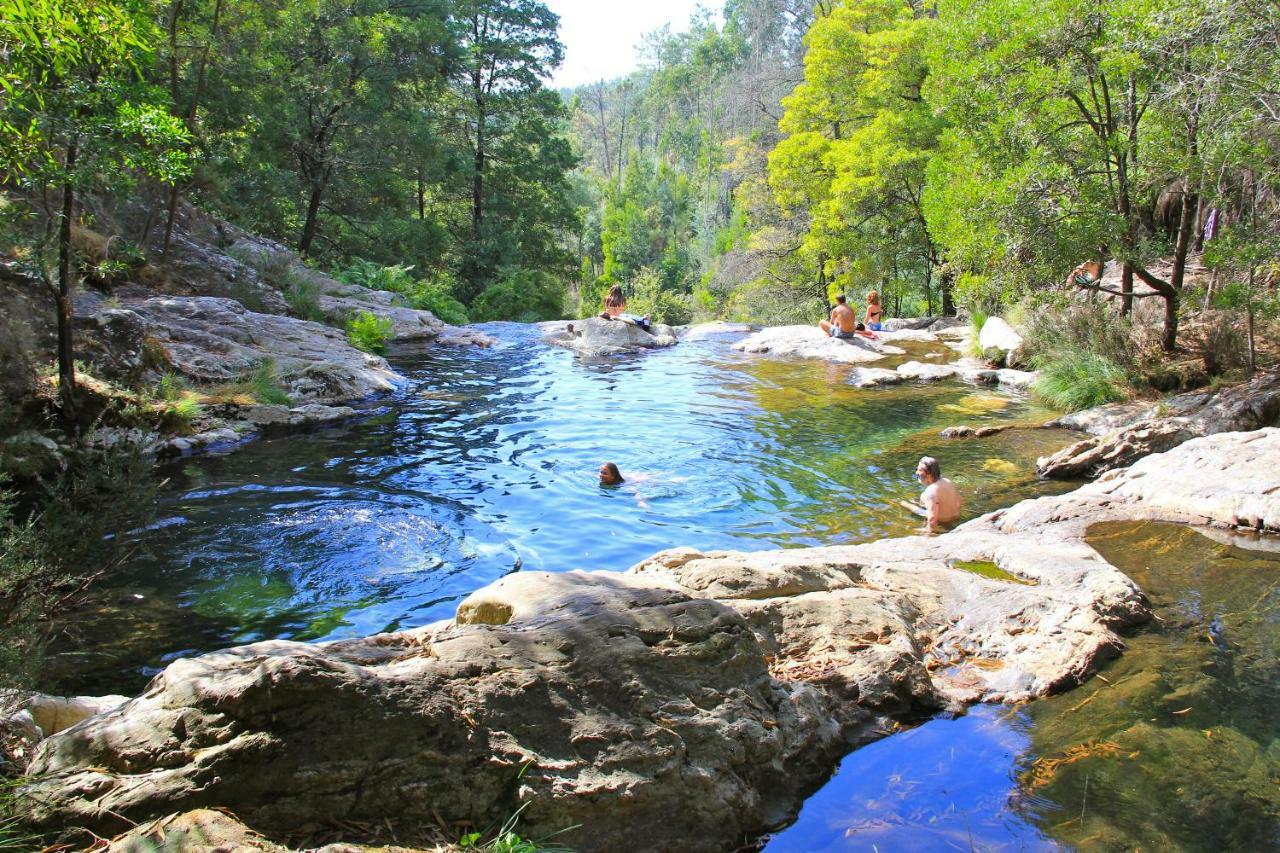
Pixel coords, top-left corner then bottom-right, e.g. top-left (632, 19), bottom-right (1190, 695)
top-left (0, 0), bottom-right (1280, 348)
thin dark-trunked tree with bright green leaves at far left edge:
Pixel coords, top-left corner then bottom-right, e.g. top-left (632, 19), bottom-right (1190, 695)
top-left (0, 0), bottom-right (188, 420)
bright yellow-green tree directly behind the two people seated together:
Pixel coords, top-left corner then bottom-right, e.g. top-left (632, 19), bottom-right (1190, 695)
top-left (769, 0), bottom-right (952, 313)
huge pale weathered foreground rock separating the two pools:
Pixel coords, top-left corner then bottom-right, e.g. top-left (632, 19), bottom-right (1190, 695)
top-left (26, 429), bottom-right (1280, 850)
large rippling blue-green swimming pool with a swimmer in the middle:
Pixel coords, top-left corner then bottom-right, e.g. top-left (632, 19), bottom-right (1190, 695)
top-left (44, 324), bottom-right (1069, 693)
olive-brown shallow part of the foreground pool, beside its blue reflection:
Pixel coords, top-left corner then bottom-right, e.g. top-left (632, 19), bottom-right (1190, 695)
top-left (1023, 523), bottom-right (1280, 850)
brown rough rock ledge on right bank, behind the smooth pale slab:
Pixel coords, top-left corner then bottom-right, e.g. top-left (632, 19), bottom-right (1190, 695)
top-left (1037, 370), bottom-right (1280, 479)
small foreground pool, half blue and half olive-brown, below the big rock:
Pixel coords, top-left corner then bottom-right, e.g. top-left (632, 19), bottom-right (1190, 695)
top-left (764, 523), bottom-right (1280, 853)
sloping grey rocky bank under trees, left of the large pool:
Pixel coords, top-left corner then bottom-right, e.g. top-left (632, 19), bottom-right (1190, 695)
top-left (0, 209), bottom-right (493, 479)
